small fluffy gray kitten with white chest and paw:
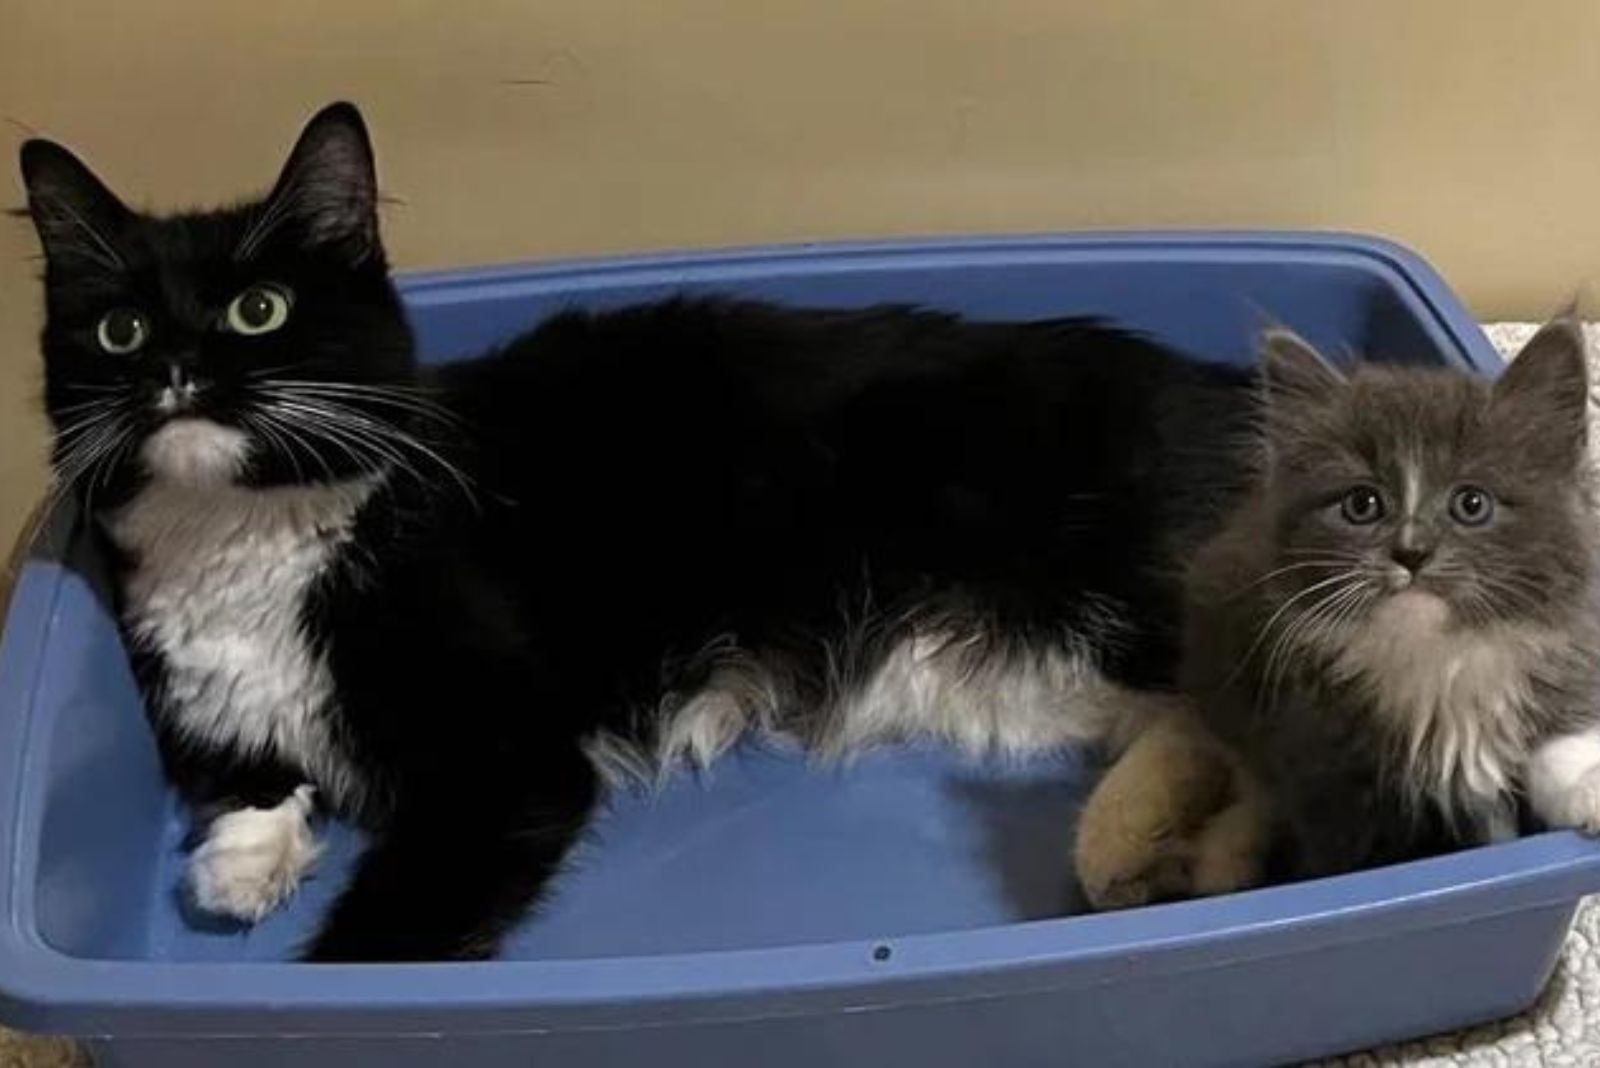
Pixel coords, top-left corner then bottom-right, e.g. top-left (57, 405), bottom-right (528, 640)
top-left (1184, 320), bottom-right (1600, 875)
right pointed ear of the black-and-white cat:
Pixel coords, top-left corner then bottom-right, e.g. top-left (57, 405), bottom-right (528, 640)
top-left (264, 102), bottom-right (378, 262)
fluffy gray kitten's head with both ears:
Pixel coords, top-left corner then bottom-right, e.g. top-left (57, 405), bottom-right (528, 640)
top-left (1262, 321), bottom-right (1594, 640)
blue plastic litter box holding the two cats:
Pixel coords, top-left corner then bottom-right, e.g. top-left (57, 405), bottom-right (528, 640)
top-left (0, 233), bottom-right (1600, 1068)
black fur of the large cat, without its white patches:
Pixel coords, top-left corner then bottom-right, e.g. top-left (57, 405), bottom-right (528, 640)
top-left (24, 106), bottom-right (1250, 959)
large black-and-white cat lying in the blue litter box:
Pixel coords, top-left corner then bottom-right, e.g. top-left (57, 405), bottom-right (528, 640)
top-left (22, 106), bottom-right (1248, 959)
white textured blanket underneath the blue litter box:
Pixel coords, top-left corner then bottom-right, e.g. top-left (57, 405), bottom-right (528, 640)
top-left (0, 323), bottom-right (1600, 1068)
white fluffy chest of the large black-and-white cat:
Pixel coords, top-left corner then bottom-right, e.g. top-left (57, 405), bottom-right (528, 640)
top-left (107, 480), bottom-right (374, 795)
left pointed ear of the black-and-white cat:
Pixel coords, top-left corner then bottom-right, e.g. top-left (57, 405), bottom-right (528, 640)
top-left (18, 137), bottom-right (131, 270)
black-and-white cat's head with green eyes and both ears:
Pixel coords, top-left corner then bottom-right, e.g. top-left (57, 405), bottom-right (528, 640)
top-left (21, 104), bottom-right (414, 491)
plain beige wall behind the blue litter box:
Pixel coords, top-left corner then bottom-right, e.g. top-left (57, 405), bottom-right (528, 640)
top-left (0, 0), bottom-right (1600, 549)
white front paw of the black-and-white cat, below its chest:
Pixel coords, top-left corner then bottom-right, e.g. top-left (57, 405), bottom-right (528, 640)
top-left (189, 787), bottom-right (322, 924)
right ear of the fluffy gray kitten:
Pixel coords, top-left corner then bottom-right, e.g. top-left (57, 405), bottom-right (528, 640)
top-left (1493, 315), bottom-right (1589, 449)
